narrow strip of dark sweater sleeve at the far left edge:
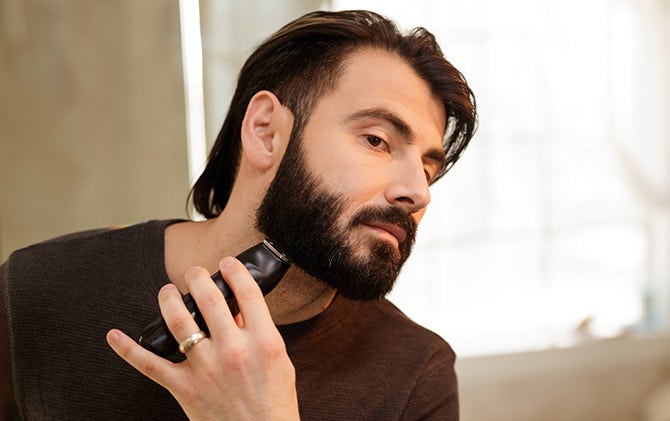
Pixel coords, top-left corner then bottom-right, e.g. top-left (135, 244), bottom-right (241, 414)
top-left (0, 263), bottom-right (20, 420)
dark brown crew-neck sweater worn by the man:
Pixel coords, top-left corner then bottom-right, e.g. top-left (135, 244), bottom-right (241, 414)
top-left (0, 221), bottom-right (458, 420)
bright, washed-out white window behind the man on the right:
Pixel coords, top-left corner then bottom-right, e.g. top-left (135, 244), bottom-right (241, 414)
top-left (328, 0), bottom-right (670, 355)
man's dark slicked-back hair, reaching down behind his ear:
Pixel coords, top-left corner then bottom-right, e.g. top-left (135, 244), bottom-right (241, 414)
top-left (191, 10), bottom-right (477, 218)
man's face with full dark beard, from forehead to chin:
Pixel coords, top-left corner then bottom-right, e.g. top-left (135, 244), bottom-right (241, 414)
top-left (257, 49), bottom-right (445, 300)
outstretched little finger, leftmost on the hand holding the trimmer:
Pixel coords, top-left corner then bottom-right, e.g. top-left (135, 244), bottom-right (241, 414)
top-left (107, 329), bottom-right (178, 388)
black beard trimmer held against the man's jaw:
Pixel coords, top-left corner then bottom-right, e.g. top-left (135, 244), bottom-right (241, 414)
top-left (138, 239), bottom-right (291, 357)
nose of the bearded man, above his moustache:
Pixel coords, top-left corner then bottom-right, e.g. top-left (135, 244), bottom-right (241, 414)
top-left (386, 161), bottom-right (430, 214)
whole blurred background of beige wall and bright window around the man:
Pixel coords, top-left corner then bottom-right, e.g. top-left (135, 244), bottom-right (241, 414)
top-left (0, 0), bottom-right (670, 421)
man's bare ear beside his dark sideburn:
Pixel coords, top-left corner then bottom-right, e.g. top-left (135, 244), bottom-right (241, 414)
top-left (241, 91), bottom-right (293, 170)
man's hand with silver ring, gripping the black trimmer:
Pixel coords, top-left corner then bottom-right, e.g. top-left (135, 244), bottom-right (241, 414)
top-left (107, 257), bottom-right (299, 420)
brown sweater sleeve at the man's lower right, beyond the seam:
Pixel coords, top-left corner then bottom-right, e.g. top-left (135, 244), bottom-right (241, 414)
top-left (402, 346), bottom-right (459, 421)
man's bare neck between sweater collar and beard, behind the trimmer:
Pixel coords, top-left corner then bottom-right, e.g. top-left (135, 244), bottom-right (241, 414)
top-left (165, 215), bottom-right (335, 325)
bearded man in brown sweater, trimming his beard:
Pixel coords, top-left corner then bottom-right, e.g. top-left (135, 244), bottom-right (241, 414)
top-left (0, 11), bottom-right (476, 420)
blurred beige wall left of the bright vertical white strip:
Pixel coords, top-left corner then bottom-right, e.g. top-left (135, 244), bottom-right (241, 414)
top-left (0, 0), bottom-right (188, 260)
